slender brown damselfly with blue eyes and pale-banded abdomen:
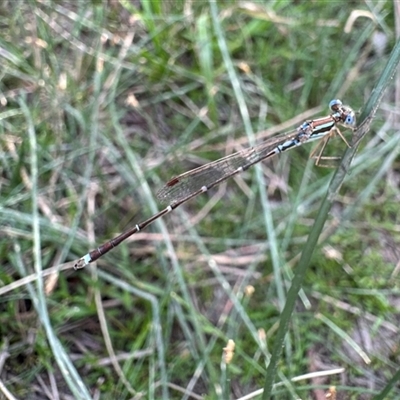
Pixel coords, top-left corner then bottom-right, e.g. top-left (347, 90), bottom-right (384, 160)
top-left (74, 100), bottom-right (356, 269)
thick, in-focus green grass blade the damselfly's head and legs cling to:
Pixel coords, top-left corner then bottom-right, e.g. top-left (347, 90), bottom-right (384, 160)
top-left (262, 35), bottom-right (400, 400)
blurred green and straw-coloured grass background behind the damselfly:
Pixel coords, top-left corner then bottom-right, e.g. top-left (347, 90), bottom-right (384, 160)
top-left (0, 0), bottom-right (400, 400)
